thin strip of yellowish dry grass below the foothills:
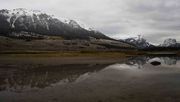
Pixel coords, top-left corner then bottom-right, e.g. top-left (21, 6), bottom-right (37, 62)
top-left (0, 51), bottom-right (140, 57)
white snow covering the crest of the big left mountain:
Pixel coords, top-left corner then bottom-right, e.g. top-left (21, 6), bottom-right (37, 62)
top-left (0, 8), bottom-right (94, 31)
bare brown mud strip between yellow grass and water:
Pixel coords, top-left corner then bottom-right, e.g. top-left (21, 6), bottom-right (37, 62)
top-left (0, 56), bottom-right (127, 65)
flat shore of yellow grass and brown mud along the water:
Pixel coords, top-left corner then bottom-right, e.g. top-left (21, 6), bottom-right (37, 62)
top-left (0, 51), bottom-right (178, 66)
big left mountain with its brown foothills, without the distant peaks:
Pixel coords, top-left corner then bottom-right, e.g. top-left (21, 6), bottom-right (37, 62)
top-left (0, 8), bottom-right (135, 51)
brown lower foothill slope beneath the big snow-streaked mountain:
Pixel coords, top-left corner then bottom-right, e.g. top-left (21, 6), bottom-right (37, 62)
top-left (0, 36), bottom-right (135, 52)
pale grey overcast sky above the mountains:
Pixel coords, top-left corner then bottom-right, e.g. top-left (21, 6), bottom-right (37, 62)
top-left (0, 0), bottom-right (180, 43)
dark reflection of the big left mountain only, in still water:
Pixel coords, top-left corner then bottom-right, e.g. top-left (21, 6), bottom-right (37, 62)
top-left (0, 64), bottom-right (107, 92)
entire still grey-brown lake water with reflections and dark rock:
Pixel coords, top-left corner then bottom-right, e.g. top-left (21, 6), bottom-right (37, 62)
top-left (0, 56), bottom-right (180, 102)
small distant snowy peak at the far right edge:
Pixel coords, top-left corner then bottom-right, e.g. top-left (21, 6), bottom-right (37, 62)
top-left (160, 38), bottom-right (180, 47)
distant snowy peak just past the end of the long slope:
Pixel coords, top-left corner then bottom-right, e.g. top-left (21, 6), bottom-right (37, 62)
top-left (120, 36), bottom-right (154, 49)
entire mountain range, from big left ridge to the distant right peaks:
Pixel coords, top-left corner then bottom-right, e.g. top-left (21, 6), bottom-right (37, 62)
top-left (0, 8), bottom-right (180, 49)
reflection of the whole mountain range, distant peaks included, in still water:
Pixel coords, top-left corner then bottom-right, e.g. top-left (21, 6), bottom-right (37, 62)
top-left (0, 56), bottom-right (180, 93)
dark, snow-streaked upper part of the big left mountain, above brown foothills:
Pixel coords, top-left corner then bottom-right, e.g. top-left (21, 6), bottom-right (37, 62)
top-left (0, 8), bottom-right (109, 39)
